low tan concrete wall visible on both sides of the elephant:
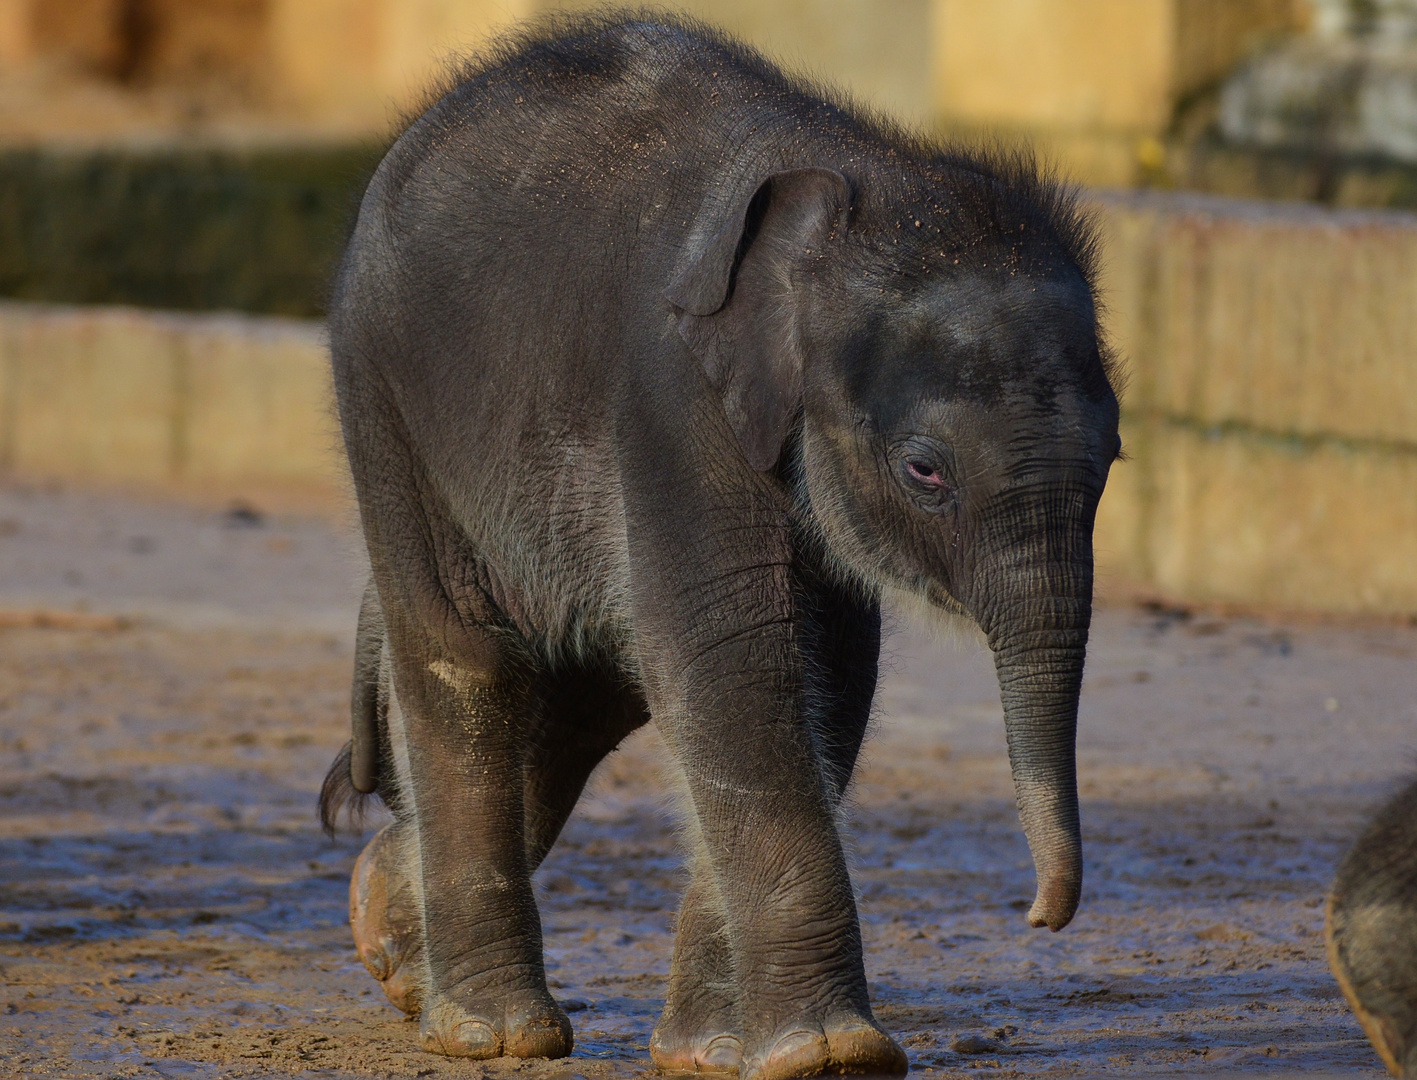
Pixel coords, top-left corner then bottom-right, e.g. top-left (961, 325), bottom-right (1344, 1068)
top-left (0, 196), bottom-right (1417, 615)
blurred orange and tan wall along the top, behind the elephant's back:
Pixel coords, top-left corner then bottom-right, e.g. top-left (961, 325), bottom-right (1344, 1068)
top-left (0, 0), bottom-right (1308, 184)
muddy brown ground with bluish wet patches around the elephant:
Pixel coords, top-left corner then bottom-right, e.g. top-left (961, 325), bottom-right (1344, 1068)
top-left (0, 488), bottom-right (1399, 1080)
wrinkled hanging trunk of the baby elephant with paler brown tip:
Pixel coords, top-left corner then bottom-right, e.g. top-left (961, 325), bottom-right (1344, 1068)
top-left (989, 592), bottom-right (1091, 930)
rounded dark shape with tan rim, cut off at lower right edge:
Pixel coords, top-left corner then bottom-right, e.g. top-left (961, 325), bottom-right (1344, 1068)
top-left (1325, 782), bottom-right (1417, 1080)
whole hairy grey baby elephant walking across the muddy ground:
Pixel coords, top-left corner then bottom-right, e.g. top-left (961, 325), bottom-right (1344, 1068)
top-left (327, 16), bottom-right (1119, 1080)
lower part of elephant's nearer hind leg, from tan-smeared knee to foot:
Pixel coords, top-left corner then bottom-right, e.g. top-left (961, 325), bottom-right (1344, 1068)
top-left (390, 642), bottom-right (571, 1059)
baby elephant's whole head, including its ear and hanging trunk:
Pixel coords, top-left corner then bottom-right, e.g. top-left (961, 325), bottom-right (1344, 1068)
top-left (665, 149), bottom-right (1121, 930)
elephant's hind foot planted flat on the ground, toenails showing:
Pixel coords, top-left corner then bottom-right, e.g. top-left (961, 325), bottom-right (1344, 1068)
top-left (418, 991), bottom-right (575, 1060)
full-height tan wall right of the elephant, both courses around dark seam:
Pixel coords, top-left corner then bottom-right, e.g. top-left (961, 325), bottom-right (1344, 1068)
top-left (1098, 196), bottom-right (1417, 612)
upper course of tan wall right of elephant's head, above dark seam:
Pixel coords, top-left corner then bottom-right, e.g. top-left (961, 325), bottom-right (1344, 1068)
top-left (1100, 194), bottom-right (1417, 445)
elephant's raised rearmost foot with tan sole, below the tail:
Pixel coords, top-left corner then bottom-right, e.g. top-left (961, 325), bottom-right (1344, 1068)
top-left (350, 822), bottom-right (425, 1016)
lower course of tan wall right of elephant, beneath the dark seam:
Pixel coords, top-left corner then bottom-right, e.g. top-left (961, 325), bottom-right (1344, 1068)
top-left (1097, 417), bottom-right (1417, 615)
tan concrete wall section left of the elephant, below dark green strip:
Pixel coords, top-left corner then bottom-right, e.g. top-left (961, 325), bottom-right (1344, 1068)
top-left (0, 303), bottom-right (346, 490)
